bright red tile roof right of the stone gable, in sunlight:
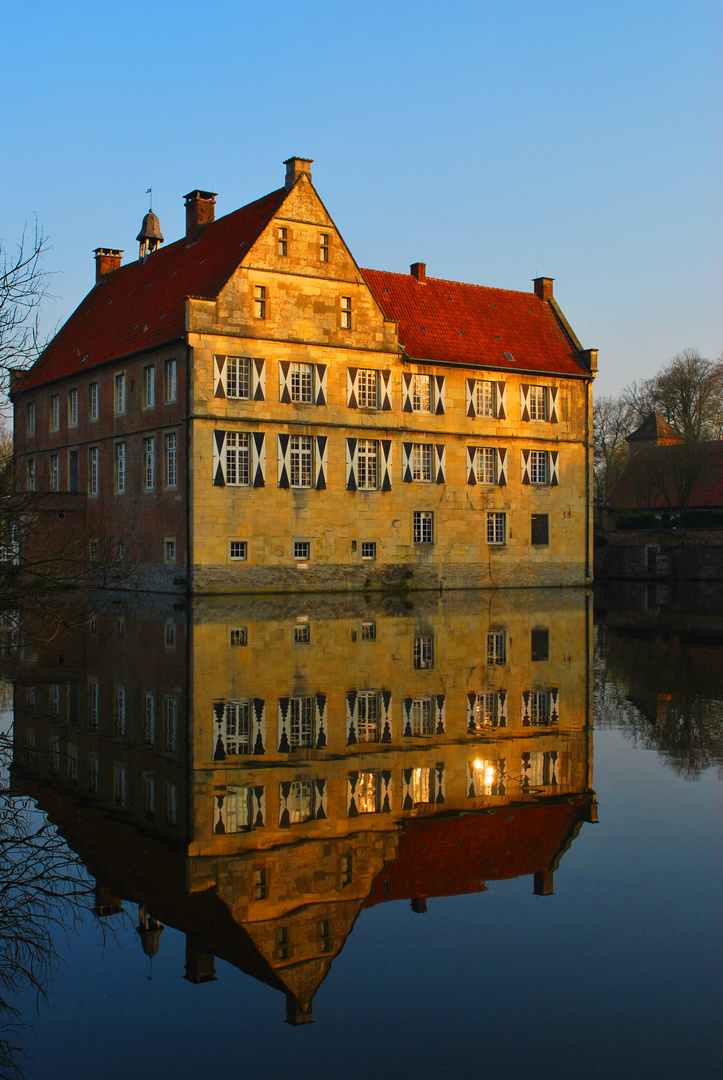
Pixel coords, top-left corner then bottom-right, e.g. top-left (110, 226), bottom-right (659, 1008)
top-left (362, 270), bottom-right (586, 375)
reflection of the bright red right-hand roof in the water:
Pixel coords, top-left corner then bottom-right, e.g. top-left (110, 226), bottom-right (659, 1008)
top-left (364, 796), bottom-right (590, 907)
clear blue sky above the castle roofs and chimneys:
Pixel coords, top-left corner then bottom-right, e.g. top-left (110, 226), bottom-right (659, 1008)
top-left (0, 0), bottom-right (723, 393)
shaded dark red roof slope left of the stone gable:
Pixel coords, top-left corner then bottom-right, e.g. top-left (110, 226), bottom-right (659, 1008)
top-left (17, 188), bottom-right (289, 390)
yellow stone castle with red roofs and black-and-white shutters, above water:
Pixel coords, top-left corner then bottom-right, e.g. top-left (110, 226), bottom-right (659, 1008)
top-left (11, 158), bottom-right (597, 592)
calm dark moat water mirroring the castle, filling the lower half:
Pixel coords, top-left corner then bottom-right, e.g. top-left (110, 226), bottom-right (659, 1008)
top-left (0, 583), bottom-right (723, 1080)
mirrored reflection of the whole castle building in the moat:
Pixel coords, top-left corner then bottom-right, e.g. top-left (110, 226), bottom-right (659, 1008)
top-left (14, 590), bottom-right (597, 1024)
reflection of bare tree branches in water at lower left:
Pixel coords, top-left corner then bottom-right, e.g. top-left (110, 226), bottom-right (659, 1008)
top-left (0, 733), bottom-right (93, 1080)
